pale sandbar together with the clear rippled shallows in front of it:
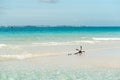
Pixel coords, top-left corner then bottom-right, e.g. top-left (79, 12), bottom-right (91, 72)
top-left (0, 41), bottom-right (120, 80)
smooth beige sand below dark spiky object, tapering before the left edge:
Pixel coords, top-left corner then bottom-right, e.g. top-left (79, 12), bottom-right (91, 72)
top-left (27, 55), bottom-right (120, 68)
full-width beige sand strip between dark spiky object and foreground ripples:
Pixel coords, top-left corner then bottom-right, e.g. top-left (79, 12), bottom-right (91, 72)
top-left (0, 55), bottom-right (120, 69)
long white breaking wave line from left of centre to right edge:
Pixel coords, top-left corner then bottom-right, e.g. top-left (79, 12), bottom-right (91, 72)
top-left (32, 37), bottom-right (120, 46)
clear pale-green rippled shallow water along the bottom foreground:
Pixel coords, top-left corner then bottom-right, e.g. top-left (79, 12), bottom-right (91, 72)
top-left (0, 68), bottom-right (120, 80)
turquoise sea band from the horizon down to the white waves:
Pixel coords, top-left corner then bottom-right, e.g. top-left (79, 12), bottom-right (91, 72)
top-left (0, 27), bottom-right (120, 44)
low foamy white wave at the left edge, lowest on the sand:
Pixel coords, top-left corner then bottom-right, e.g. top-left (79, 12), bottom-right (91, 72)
top-left (0, 54), bottom-right (33, 60)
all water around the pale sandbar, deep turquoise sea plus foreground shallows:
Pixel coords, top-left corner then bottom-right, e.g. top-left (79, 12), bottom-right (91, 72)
top-left (0, 27), bottom-right (120, 80)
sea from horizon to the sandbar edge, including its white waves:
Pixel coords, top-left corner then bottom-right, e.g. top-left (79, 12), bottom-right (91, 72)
top-left (0, 26), bottom-right (120, 55)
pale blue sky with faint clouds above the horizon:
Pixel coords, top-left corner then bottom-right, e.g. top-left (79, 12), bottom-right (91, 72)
top-left (0, 0), bottom-right (120, 26)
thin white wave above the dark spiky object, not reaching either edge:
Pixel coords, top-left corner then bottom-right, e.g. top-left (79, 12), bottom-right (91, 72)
top-left (33, 41), bottom-right (95, 46)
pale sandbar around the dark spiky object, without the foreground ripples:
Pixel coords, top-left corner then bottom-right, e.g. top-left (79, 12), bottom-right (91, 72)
top-left (0, 41), bottom-right (120, 68)
